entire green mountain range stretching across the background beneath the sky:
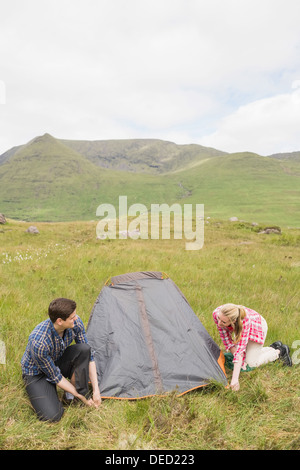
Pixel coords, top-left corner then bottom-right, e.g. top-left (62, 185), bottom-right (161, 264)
top-left (0, 134), bottom-right (300, 227)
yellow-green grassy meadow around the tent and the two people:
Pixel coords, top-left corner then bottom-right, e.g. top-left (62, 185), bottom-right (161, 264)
top-left (0, 219), bottom-right (300, 450)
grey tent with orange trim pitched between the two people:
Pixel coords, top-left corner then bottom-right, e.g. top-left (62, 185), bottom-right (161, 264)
top-left (87, 272), bottom-right (227, 399)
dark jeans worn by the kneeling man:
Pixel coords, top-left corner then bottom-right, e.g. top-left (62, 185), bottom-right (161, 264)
top-left (23, 343), bottom-right (91, 421)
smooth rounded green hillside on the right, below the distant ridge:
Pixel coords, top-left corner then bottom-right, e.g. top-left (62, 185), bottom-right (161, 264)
top-left (175, 153), bottom-right (300, 227)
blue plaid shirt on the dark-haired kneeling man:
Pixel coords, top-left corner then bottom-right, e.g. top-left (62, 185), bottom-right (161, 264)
top-left (21, 316), bottom-right (94, 384)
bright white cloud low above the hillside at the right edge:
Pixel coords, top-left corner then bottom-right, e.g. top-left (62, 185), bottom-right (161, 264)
top-left (201, 88), bottom-right (300, 155)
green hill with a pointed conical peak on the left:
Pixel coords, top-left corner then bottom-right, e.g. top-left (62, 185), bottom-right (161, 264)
top-left (0, 136), bottom-right (180, 221)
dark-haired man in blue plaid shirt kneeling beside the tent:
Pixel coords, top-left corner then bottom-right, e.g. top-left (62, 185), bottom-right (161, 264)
top-left (21, 298), bottom-right (101, 421)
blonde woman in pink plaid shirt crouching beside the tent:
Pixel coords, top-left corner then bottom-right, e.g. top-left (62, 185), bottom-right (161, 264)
top-left (213, 303), bottom-right (292, 391)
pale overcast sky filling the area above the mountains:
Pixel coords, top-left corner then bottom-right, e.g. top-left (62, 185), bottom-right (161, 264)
top-left (0, 0), bottom-right (300, 156)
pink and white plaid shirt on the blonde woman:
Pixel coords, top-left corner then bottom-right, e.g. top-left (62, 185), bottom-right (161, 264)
top-left (213, 305), bottom-right (265, 363)
